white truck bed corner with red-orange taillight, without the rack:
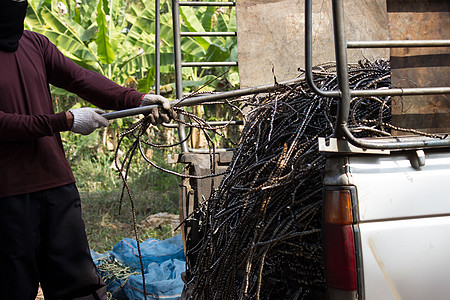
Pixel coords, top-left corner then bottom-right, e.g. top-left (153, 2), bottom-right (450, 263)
top-left (324, 144), bottom-right (450, 300)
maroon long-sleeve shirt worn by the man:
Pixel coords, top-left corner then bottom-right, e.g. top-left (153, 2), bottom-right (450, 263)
top-left (0, 31), bottom-right (143, 197)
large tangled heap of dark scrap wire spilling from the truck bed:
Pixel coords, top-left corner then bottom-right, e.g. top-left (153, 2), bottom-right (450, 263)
top-left (187, 61), bottom-right (390, 300)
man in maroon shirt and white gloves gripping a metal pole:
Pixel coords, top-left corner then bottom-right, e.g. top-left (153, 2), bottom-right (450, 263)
top-left (0, 0), bottom-right (170, 300)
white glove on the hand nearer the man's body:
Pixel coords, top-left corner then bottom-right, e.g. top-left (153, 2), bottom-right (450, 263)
top-left (69, 107), bottom-right (109, 135)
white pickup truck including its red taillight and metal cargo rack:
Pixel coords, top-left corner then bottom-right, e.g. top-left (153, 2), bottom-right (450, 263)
top-left (305, 0), bottom-right (450, 300)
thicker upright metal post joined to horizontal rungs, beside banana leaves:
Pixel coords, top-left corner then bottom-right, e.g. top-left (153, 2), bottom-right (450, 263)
top-left (172, 0), bottom-right (189, 153)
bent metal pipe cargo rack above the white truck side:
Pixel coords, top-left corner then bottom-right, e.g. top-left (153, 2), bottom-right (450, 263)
top-left (305, 0), bottom-right (450, 150)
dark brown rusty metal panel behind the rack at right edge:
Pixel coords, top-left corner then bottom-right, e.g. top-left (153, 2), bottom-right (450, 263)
top-left (387, 0), bottom-right (450, 133)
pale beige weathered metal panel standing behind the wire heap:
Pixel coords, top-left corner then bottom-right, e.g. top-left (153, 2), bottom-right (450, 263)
top-left (236, 0), bottom-right (389, 87)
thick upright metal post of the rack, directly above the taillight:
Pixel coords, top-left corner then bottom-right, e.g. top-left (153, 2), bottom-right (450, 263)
top-left (332, 0), bottom-right (350, 137)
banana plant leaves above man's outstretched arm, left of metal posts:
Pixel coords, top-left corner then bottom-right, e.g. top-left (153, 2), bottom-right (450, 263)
top-left (25, 0), bottom-right (170, 91)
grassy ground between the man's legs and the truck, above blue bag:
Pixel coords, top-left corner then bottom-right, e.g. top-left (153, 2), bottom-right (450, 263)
top-left (79, 148), bottom-right (180, 252)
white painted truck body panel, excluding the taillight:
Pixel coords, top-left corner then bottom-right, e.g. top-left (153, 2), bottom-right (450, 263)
top-left (324, 150), bottom-right (450, 300)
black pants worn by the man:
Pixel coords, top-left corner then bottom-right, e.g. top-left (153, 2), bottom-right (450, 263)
top-left (0, 184), bottom-right (106, 300)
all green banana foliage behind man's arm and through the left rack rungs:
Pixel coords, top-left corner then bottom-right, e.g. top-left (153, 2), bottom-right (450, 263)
top-left (25, 0), bottom-right (238, 94)
